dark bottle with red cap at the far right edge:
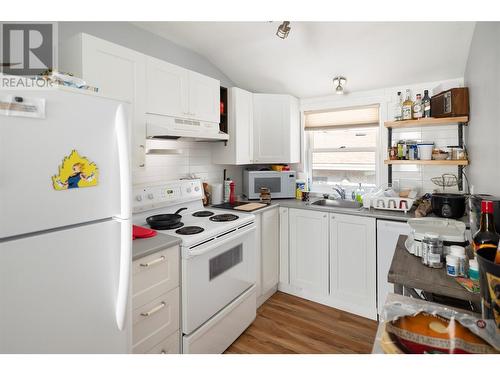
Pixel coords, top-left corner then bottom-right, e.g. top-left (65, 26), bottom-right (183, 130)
top-left (472, 201), bottom-right (500, 261)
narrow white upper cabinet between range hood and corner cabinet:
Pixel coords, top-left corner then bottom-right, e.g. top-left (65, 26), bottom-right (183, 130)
top-left (212, 87), bottom-right (253, 165)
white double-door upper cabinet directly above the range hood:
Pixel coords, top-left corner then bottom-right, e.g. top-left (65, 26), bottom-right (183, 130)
top-left (146, 57), bottom-right (220, 123)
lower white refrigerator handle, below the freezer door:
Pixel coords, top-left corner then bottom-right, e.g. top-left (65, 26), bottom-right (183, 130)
top-left (116, 220), bottom-right (132, 331)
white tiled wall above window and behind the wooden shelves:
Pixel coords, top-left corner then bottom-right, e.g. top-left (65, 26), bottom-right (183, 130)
top-left (301, 78), bottom-right (463, 194)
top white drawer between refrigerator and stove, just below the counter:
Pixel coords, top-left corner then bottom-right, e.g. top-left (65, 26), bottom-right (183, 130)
top-left (132, 246), bottom-right (179, 309)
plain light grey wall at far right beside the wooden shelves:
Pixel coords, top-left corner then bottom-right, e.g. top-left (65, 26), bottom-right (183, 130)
top-left (464, 22), bottom-right (500, 196)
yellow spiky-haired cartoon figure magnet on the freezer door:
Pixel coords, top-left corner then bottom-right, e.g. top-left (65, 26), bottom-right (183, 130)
top-left (52, 150), bottom-right (99, 190)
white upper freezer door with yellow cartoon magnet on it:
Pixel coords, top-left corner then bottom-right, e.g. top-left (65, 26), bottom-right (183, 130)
top-left (0, 90), bottom-right (131, 238)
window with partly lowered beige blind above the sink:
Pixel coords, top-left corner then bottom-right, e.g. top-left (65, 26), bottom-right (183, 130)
top-left (305, 106), bottom-right (379, 187)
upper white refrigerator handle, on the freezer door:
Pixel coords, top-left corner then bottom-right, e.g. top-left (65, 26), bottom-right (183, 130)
top-left (115, 104), bottom-right (132, 219)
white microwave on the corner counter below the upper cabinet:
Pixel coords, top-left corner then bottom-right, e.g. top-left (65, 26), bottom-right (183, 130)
top-left (243, 170), bottom-right (297, 199)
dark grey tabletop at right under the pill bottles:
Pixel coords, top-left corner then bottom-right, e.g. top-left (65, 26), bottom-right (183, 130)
top-left (387, 235), bottom-right (481, 304)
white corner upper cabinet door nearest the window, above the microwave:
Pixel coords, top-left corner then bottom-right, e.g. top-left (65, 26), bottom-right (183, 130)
top-left (253, 94), bottom-right (300, 164)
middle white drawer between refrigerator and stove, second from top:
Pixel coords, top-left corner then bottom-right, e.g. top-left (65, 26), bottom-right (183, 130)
top-left (132, 288), bottom-right (179, 345)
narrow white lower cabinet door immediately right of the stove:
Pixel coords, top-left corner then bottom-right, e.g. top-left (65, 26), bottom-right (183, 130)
top-left (254, 207), bottom-right (280, 306)
